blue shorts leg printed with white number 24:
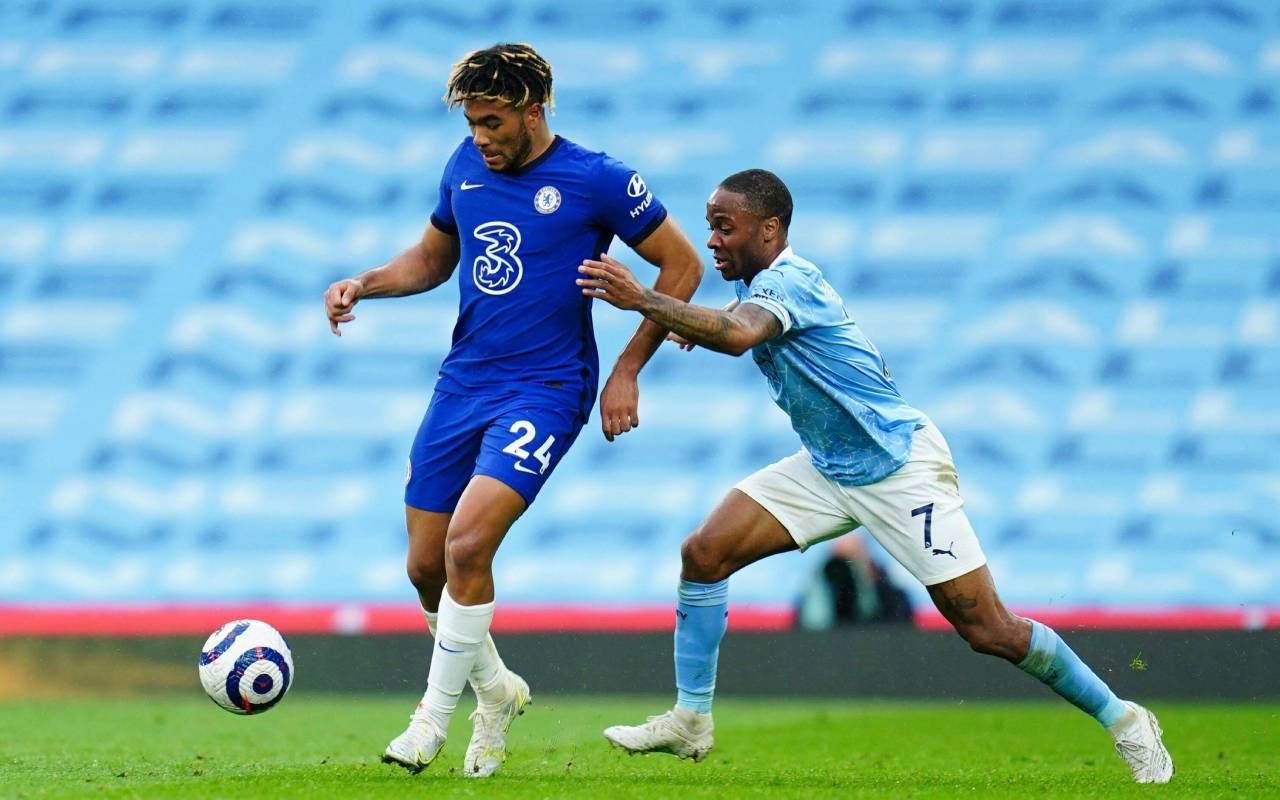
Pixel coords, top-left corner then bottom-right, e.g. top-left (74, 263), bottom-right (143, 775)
top-left (475, 399), bottom-right (584, 506)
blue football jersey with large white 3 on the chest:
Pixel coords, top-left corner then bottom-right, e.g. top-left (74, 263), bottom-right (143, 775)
top-left (431, 136), bottom-right (667, 413)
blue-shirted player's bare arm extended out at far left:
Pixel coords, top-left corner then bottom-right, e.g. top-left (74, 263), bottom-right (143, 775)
top-left (324, 223), bottom-right (458, 337)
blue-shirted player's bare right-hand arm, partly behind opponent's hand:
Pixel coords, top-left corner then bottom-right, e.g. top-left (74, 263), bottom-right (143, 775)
top-left (600, 216), bottom-right (703, 442)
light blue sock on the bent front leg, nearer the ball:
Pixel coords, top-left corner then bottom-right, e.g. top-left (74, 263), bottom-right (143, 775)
top-left (676, 577), bottom-right (728, 713)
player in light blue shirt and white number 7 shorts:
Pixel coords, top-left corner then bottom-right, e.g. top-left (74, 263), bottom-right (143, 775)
top-left (579, 169), bottom-right (1174, 783)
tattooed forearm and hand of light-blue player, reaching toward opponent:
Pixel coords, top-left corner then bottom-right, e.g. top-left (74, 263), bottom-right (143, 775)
top-left (577, 256), bottom-right (782, 356)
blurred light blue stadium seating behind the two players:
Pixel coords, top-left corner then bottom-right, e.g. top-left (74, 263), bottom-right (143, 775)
top-left (0, 0), bottom-right (1280, 622)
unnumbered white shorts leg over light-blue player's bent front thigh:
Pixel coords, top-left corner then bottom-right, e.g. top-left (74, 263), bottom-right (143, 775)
top-left (733, 451), bottom-right (859, 550)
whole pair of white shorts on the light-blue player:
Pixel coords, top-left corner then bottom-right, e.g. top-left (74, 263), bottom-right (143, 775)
top-left (735, 422), bottom-right (987, 586)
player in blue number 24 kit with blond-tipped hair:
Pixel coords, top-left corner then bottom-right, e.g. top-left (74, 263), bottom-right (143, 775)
top-left (325, 44), bottom-right (701, 777)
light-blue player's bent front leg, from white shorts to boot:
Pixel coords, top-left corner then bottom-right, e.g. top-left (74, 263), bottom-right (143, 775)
top-left (604, 452), bottom-right (858, 762)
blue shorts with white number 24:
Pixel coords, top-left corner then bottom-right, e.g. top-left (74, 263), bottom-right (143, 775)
top-left (404, 387), bottom-right (585, 512)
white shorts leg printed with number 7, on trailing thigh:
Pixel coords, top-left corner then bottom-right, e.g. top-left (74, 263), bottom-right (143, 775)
top-left (844, 422), bottom-right (987, 586)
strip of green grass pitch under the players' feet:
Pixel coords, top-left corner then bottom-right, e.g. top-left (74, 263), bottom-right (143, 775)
top-left (0, 694), bottom-right (1280, 800)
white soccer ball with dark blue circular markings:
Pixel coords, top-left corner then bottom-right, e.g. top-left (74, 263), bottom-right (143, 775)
top-left (200, 620), bottom-right (293, 714)
